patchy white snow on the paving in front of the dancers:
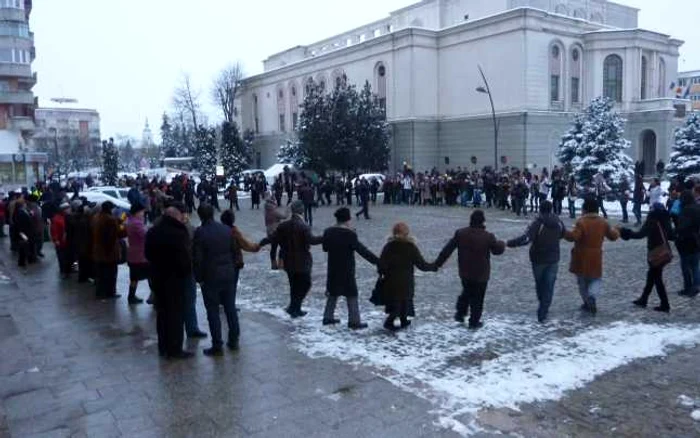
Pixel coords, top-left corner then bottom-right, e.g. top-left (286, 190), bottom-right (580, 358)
top-left (240, 294), bottom-right (700, 436)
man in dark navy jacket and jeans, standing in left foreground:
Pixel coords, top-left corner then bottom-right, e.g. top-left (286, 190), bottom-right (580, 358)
top-left (194, 204), bottom-right (240, 356)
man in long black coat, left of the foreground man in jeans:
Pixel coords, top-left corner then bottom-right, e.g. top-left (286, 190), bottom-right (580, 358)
top-left (145, 203), bottom-right (193, 359)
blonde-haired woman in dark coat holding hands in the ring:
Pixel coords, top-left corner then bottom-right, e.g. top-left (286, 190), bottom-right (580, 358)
top-left (379, 222), bottom-right (437, 331)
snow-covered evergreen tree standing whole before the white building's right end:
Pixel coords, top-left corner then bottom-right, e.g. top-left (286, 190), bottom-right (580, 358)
top-left (557, 97), bottom-right (633, 187)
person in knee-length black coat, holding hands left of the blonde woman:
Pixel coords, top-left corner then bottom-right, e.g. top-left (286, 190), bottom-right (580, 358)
top-left (323, 207), bottom-right (379, 330)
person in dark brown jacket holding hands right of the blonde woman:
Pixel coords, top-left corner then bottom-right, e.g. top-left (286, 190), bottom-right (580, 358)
top-left (435, 210), bottom-right (506, 329)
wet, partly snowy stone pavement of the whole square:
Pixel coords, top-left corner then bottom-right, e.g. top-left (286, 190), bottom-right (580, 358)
top-left (0, 200), bottom-right (700, 437)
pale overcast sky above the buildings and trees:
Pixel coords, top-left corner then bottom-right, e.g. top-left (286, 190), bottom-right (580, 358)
top-left (30, 0), bottom-right (700, 139)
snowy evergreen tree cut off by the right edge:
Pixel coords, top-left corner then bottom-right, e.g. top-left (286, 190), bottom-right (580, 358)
top-left (666, 113), bottom-right (700, 180)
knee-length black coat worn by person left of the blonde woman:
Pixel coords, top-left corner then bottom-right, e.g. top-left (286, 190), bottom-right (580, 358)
top-left (323, 226), bottom-right (379, 297)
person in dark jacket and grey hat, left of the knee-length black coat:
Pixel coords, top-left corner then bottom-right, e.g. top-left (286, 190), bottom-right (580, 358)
top-left (260, 200), bottom-right (323, 318)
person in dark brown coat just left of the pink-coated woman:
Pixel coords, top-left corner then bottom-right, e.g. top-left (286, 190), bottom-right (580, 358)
top-left (92, 201), bottom-right (126, 299)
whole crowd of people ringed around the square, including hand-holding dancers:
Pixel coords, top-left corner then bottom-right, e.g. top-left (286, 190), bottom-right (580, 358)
top-left (0, 164), bottom-right (700, 359)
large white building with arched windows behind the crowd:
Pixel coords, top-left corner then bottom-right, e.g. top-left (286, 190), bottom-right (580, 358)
top-left (238, 0), bottom-right (690, 174)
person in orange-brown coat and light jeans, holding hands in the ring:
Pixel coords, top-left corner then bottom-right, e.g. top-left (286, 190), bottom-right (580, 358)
top-left (564, 198), bottom-right (620, 315)
